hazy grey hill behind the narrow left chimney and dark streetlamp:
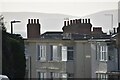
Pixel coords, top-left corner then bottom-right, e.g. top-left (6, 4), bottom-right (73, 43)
top-left (2, 12), bottom-right (77, 37)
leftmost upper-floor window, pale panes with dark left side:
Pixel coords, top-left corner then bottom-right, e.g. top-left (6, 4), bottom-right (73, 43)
top-left (37, 45), bottom-right (46, 60)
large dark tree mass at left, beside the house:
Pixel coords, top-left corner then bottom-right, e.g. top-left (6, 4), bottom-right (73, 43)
top-left (0, 14), bottom-right (26, 80)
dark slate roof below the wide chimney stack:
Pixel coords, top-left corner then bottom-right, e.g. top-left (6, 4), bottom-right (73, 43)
top-left (40, 31), bottom-right (111, 40)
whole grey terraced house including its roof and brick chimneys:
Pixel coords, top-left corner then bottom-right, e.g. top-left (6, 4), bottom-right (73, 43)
top-left (25, 19), bottom-right (120, 80)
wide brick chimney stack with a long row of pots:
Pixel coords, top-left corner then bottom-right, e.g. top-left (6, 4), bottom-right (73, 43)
top-left (62, 19), bottom-right (92, 35)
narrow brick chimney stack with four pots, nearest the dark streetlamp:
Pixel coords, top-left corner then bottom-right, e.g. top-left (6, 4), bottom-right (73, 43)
top-left (27, 19), bottom-right (40, 38)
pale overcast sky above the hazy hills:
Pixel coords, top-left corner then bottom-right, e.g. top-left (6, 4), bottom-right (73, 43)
top-left (0, 0), bottom-right (119, 16)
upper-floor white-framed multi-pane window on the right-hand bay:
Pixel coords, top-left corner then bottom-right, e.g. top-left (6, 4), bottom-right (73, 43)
top-left (100, 46), bottom-right (108, 61)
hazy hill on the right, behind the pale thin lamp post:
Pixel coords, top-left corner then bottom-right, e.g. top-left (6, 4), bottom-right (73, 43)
top-left (82, 10), bottom-right (118, 32)
